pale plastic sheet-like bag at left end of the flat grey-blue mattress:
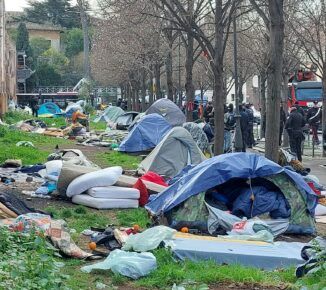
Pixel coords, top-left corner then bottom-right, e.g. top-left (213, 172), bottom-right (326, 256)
top-left (122, 226), bottom-right (176, 252)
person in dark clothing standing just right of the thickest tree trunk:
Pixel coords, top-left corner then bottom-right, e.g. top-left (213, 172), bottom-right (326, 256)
top-left (285, 107), bottom-right (305, 162)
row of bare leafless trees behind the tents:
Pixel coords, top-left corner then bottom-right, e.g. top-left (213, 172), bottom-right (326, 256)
top-left (92, 0), bottom-right (326, 160)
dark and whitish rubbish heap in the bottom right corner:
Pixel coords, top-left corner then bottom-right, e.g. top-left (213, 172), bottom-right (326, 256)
top-left (296, 237), bottom-right (326, 278)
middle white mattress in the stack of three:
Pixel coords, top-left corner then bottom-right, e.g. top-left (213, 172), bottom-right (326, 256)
top-left (87, 186), bottom-right (140, 199)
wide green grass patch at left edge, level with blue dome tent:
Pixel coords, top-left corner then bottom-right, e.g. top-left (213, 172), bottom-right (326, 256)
top-left (0, 126), bottom-right (70, 165)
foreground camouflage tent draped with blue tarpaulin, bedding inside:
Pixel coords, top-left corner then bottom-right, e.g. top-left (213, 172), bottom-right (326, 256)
top-left (146, 153), bottom-right (317, 234)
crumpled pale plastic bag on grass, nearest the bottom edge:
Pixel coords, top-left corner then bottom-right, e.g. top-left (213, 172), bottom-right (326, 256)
top-left (81, 250), bottom-right (157, 279)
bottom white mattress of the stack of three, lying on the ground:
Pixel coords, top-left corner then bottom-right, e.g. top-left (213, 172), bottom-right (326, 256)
top-left (72, 194), bottom-right (138, 209)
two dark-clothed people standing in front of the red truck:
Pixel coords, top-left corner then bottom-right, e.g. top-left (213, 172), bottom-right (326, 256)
top-left (285, 101), bottom-right (322, 161)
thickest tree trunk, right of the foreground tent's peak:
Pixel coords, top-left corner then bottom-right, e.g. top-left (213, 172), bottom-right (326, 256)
top-left (265, 0), bottom-right (284, 162)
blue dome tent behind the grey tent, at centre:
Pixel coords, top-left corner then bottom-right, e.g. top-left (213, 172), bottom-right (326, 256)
top-left (119, 114), bottom-right (172, 152)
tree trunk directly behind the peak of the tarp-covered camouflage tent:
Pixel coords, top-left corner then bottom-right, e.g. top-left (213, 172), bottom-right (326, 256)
top-left (211, 0), bottom-right (225, 155)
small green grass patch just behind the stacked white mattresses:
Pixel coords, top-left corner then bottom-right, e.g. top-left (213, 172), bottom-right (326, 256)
top-left (96, 151), bottom-right (141, 169)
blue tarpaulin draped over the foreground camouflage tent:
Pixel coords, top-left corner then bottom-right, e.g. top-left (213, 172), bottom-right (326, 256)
top-left (146, 153), bottom-right (317, 215)
